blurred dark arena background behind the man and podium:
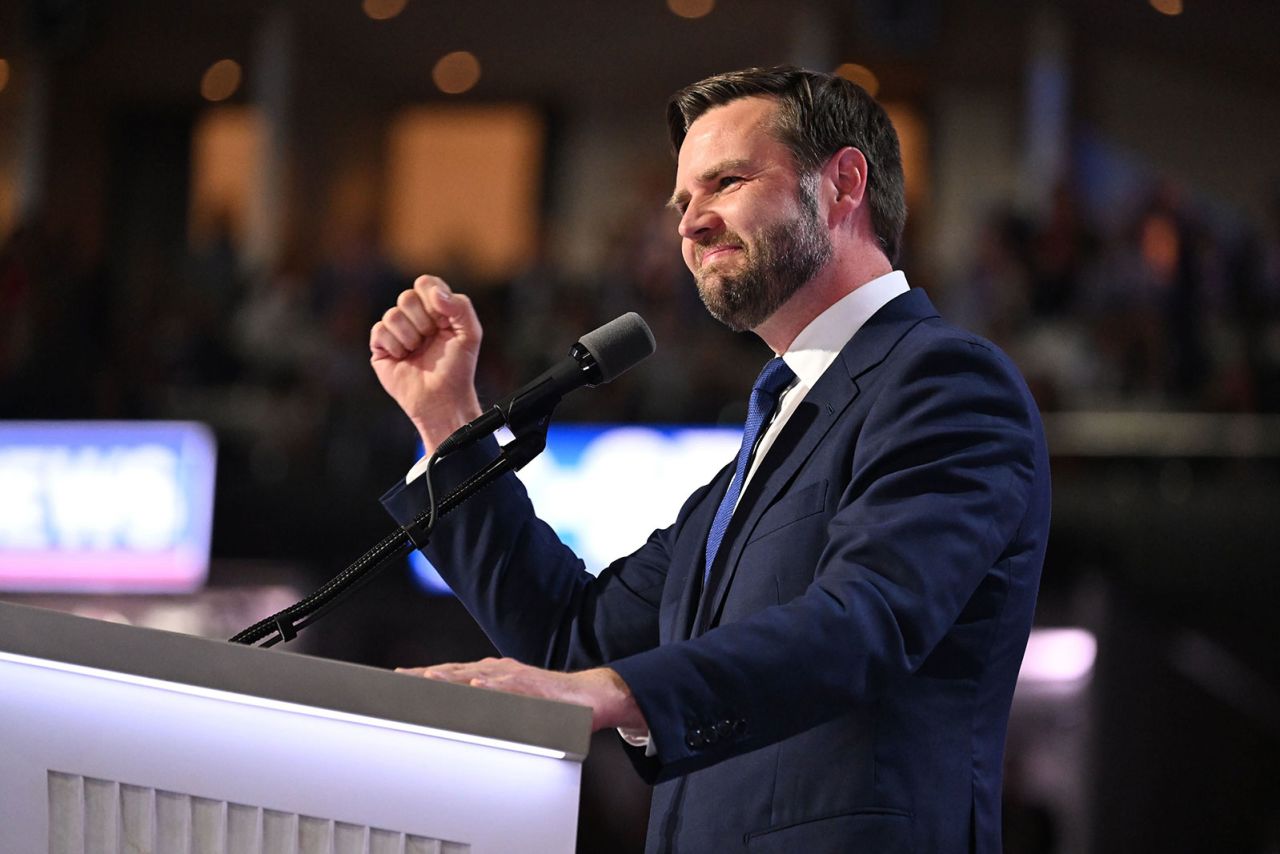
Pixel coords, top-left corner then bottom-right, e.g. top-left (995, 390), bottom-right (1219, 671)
top-left (0, 0), bottom-right (1280, 854)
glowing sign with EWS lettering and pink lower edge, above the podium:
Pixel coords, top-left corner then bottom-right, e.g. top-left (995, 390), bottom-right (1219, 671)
top-left (0, 421), bottom-right (215, 593)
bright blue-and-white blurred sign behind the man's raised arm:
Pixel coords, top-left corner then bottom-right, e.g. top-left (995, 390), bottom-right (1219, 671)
top-left (411, 425), bottom-right (742, 592)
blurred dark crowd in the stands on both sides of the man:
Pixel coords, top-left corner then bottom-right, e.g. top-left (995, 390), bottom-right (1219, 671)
top-left (0, 175), bottom-right (1280, 494)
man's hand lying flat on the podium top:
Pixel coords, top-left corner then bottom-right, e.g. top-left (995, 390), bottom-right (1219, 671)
top-left (396, 658), bottom-right (649, 732)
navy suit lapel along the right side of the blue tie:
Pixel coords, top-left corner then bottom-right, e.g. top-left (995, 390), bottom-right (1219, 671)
top-left (681, 289), bottom-right (937, 635)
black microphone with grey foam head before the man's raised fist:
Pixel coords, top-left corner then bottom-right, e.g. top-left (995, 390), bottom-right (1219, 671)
top-left (435, 311), bottom-right (657, 458)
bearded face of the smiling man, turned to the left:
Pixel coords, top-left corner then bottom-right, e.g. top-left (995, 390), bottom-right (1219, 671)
top-left (671, 97), bottom-right (832, 330)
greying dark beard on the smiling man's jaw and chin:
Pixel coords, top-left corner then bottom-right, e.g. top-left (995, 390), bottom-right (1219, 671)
top-left (695, 175), bottom-right (832, 332)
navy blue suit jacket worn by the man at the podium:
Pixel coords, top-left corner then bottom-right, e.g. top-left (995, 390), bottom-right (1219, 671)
top-left (384, 291), bottom-right (1050, 854)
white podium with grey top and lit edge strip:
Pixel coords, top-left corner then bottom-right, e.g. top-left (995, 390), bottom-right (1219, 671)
top-left (0, 603), bottom-right (591, 854)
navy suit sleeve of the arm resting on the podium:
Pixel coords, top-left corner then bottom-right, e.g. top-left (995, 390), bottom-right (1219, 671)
top-left (611, 337), bottom-right (1047, 778)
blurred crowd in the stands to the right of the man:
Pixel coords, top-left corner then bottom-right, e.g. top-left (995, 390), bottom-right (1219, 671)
top-left (941, 186), bottom-right (1280, 412)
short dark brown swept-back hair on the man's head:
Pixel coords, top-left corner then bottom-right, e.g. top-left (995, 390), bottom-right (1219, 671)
top-left (667, 65), bottom-right (906, 264)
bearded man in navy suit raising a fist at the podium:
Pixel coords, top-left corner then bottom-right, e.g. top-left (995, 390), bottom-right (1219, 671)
top-left (371, 68), bottom-right (1050, 854)
